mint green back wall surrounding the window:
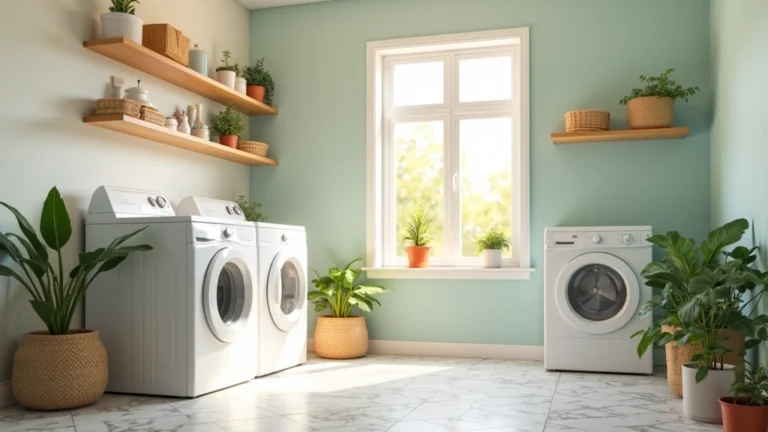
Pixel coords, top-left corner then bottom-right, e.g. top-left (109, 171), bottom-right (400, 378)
top-left (251, 0), bottom-right (711, 345)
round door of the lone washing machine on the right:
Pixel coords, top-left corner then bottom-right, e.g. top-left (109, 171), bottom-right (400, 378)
top-left (555, 252), bottom-right (640, 334)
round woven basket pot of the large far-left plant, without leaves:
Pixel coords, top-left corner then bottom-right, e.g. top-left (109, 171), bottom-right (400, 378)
top-left (11, 330), bottom-right (109, 411)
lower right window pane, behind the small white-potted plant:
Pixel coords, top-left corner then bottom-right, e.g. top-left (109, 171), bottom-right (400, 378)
top-left (459, 117), bottom-right (512, 257)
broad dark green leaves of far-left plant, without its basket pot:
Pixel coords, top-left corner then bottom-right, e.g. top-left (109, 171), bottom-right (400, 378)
top-left (0, 187), bottom-right (152, 335)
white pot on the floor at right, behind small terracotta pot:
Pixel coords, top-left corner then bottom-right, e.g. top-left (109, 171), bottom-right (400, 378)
top-left (682, 363), bottom-right (736, 423)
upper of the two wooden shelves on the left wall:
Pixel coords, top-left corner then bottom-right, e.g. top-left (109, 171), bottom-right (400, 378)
top-left (83, 38), bottom-right (277, 116)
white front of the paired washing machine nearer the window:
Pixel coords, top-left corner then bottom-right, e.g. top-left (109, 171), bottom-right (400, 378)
top-left (256, 223), bottom-right (307, 376)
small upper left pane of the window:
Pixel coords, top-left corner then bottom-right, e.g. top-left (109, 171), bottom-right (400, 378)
top-left (394, 61), bottom-right (444, 106)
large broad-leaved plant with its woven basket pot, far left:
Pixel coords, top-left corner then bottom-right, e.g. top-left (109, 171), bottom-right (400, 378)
top-left (0, 187), bottom-right (152, 410)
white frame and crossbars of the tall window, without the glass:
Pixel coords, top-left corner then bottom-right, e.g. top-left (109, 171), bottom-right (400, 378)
top-left (366, 27), bottom-right (533, 279)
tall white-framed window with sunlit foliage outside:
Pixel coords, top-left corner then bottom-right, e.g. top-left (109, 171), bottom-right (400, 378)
top-left (367, 28), bottom-right (530, 278)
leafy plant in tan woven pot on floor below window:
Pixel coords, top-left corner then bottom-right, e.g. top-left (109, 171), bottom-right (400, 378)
top-left (307, 258), bottom-right (387, 359)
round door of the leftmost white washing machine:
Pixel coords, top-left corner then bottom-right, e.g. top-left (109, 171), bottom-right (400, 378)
top-left (203, 248), bottom-right (253, 342)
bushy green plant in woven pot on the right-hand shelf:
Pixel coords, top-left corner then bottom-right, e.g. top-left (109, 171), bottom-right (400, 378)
top-left (620, 69), bottom-right (699, 129)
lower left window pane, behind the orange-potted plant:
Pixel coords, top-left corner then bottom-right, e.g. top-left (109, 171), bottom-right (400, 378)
top-left (394, 121), bottom-right (444, 256)
